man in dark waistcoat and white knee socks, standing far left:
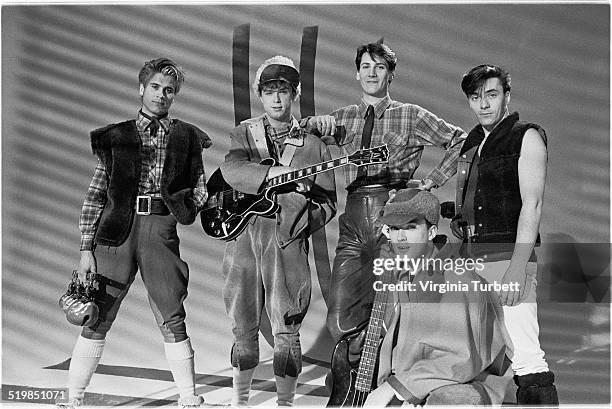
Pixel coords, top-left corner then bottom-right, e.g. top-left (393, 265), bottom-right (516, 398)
top-left (63, 58), bottom-right (211, 407)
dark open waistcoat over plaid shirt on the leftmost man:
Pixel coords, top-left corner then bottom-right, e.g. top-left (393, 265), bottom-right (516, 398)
top-left (91, 119), bottom-right (211, 246)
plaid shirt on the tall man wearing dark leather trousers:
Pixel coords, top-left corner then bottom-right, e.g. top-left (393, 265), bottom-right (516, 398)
top-left (318, 95), bottom-right (467, 186)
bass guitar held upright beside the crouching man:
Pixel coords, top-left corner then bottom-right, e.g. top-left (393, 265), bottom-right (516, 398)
top-left (327, 264), bottom-right (393, 407)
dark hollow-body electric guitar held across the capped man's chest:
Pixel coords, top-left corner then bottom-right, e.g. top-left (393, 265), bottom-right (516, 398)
top-left (200, 145), bottom-right (389, 241)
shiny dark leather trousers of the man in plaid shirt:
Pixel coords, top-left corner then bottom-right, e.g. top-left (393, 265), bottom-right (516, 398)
top-left (327, 186), bottom-right (389, 341)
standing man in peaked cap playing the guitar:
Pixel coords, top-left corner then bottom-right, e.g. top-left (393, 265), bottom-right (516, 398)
top-left (221, 56), bottom-right (336, 406)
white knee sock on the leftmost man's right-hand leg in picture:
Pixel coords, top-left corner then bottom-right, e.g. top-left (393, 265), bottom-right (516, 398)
top-left (164, 338), bottom-right (195, 398)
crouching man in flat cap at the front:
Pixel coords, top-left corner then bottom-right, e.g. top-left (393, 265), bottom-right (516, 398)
top-left (366, 189), bottom-right (507, 406)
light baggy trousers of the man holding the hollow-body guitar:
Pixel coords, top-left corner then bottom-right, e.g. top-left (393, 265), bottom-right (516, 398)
top-left (223, 217), bottom-right (311, 377)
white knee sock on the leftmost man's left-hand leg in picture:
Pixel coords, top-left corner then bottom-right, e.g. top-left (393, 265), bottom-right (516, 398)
top-left (68, 335), bottom-right (106, 399)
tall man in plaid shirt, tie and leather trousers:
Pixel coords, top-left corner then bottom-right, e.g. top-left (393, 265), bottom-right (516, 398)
top-left (302, 43), bottom-right (466, 350)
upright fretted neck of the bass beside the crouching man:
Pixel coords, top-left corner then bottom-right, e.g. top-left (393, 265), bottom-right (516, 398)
top-left (355, 271), bottom-right (391, 392)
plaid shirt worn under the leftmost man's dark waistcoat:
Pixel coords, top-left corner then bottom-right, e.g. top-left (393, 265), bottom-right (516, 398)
top-left (79, 112), bottom-right (208, 250)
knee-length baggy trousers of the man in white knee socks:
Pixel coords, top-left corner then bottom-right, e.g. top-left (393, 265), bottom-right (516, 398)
top-left (81, 215), bottom-right (189, 342)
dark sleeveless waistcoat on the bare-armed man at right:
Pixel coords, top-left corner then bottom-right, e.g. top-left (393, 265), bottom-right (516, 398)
top-left (457, 112), bottom-right (546, 252)
